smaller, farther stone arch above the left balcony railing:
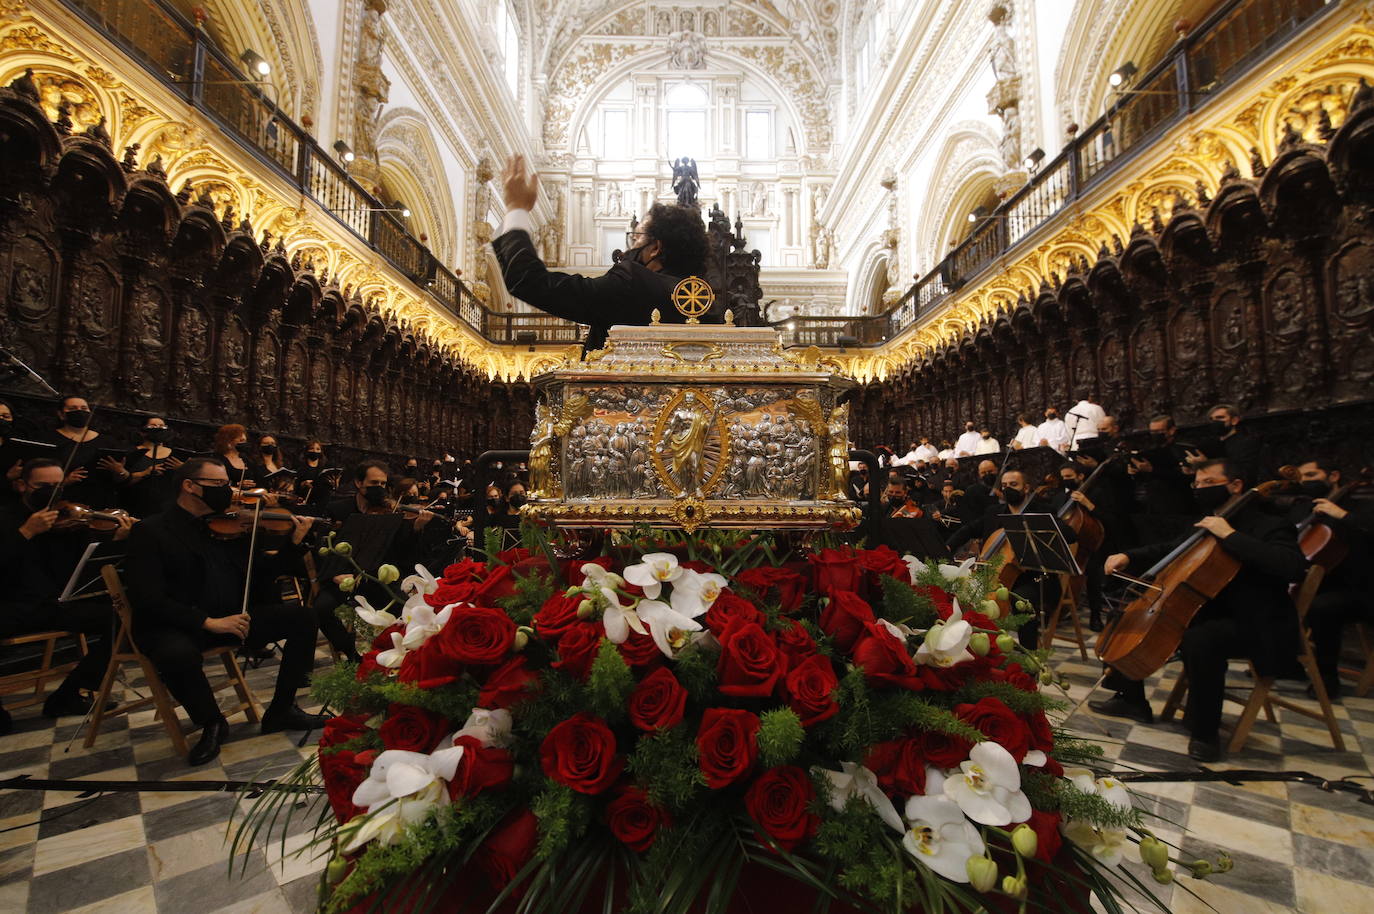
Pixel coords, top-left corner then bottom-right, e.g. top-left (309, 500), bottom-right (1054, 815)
top-left (376, 107), bottom-right (458, 267)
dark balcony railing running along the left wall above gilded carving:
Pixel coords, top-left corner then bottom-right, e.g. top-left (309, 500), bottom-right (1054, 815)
top-left (63, 0), bottom-right (508, 342)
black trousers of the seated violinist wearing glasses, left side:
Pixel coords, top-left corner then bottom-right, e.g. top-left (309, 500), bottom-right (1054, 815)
top-left (136, 603), bottom-right (319, 727)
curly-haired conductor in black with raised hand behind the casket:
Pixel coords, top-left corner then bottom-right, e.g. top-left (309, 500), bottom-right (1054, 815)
top-left (492, 155), bottom-right (706, 350)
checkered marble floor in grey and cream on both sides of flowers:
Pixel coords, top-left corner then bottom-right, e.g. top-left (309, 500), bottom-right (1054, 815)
top-left (0, 621), bottom-right (1374, 914)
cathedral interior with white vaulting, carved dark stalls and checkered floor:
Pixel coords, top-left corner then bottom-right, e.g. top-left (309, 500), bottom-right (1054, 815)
top-left (0, 0), bottom-right (1374, 914)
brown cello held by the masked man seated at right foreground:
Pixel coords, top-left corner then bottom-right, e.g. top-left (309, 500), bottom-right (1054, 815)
top-left (1096, 481), bottom-right (1283, 680)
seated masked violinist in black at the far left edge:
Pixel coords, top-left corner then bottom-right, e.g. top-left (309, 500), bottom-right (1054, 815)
top-left (0, 458), bottom-right (133, 717)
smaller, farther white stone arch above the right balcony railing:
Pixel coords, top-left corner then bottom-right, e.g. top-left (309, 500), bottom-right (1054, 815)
top-left (916, 121), bottom-right (1006, 264)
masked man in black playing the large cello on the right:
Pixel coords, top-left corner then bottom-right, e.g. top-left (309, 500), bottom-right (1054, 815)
top-left (1088, 459), bottom-right (1307, 761)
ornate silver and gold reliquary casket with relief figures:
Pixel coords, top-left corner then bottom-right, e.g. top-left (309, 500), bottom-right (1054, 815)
top-left (523, 324), bottom-right (860, 532)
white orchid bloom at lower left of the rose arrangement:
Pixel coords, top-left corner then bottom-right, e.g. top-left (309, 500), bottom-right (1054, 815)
top-left (344, 746), bottom-right (463, 854)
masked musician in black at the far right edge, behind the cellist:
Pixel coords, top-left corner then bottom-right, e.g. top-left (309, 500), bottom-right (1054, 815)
top-left (1289, 458), bottom-right (1374, 701)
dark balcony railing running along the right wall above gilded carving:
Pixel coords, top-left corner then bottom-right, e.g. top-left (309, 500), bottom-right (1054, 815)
top-left (778, 0), bottom-right (1338, 345)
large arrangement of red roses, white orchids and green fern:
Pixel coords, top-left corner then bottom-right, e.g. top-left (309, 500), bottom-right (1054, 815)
top-left (236, 531), bottom-right (1224, 914)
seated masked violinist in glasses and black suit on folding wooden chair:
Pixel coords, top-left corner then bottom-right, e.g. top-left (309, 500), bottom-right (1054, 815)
top-left (125, 458), bottom-right (324, 766)
